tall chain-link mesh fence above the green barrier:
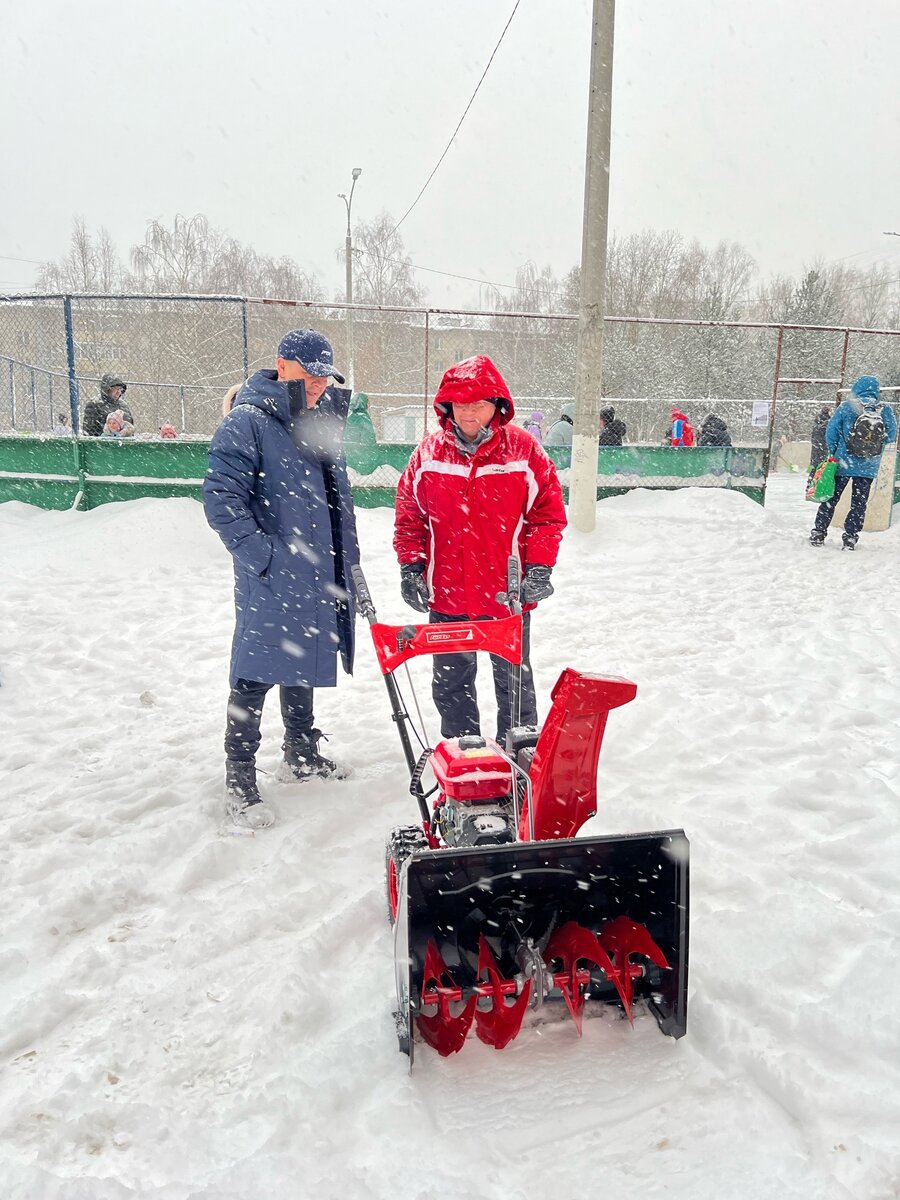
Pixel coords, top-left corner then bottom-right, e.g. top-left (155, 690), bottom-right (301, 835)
top-left (0, 295), bottom-right (900, 463)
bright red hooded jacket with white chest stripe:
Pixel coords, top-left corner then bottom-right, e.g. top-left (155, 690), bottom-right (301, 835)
top-left (394, 354), bottom-right (566, 617)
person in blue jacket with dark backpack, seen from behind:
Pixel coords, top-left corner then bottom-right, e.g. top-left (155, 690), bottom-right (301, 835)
top-left (809, 376), bottom-right (896, 550)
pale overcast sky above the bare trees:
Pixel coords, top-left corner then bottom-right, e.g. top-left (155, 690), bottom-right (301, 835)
top-left (0, 0), bottom-right (900, 306)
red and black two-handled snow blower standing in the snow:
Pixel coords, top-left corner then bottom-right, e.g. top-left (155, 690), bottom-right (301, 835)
top-left (353, 559), bottom-right (689, 1069)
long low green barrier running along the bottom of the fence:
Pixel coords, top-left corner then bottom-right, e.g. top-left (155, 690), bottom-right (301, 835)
top-left (0, 434), bottom-right (782, 509)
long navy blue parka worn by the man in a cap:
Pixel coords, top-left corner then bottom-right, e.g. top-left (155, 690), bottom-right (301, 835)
top-left (203, 371), bottom-right (359, 688)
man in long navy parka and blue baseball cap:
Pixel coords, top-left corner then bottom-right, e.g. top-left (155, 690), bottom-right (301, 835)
top-left (203, 329), bottom-right (359, 828)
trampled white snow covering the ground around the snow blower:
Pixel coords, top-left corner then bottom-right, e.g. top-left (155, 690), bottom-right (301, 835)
top-left (0, 475), bottom-right (900, 1200)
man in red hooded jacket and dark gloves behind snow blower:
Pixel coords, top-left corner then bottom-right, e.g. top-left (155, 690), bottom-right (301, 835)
top-left (394, 354), bottom-right (565, 743)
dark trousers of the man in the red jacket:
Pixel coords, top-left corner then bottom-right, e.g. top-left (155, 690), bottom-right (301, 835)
top-left (428, 612), bottom-right (538, 744)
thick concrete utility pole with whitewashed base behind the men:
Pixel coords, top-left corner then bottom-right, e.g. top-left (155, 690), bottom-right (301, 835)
top-left (569, 0), bottom-right (616, 533)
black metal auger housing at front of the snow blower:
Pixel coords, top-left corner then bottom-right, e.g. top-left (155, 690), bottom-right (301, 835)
top-left (396, 829), bottom-right (689, 1052)
